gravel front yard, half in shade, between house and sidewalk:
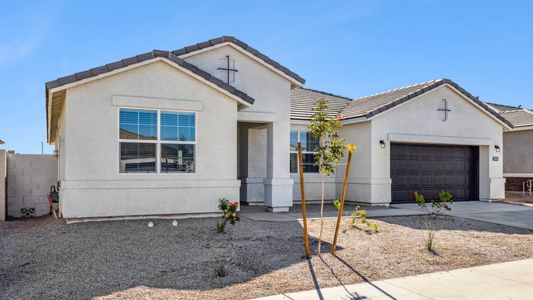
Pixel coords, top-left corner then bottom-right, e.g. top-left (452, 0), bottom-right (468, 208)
top-left (0, 216), bottom-right (533, 299)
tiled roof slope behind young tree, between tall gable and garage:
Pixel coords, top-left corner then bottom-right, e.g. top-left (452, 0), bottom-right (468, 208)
top-left (291, 88), bottom-right (351, 120)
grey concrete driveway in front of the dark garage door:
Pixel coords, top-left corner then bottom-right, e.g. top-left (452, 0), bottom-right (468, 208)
top-left (391, 201), bottom-right (533, 230)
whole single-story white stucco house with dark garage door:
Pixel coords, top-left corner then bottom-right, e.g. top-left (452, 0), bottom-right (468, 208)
top-left (46, 36), bottom-right (512, 218)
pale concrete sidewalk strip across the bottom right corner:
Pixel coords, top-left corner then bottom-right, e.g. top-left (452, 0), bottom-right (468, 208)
top-left (252, 259), bottom-right (533, 300)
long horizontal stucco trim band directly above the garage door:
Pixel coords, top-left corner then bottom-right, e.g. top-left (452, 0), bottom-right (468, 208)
top-left (388, 133), bottom-right (492, 146)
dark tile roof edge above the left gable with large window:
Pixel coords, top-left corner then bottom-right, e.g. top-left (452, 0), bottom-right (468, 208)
top-left (46, 50), bottom-right (254, 107)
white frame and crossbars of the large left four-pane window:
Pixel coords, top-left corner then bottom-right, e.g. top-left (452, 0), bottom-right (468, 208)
top-left (117, 106), bottom-right (198, 176)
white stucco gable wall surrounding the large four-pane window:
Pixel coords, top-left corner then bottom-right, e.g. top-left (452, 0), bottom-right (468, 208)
top-left (60, 61), bottom-right (240, 218)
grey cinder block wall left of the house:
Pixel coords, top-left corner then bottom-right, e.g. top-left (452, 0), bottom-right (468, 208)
top-left (7, 154), bottom-right (57, 218)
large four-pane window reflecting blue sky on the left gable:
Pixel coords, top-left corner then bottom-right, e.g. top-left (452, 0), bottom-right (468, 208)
top-left (119, 108), bottom-right (196, 173)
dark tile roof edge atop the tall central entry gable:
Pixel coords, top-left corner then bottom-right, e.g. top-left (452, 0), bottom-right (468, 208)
top-left (172, 36), bottom-right (305, 84)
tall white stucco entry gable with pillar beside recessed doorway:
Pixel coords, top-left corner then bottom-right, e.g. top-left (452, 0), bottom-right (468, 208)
top-left (183, 45), bottom-right (293, 210)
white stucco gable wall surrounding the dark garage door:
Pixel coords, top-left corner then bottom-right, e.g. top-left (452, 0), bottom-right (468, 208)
top-left (370, 86), bottom-right (506, 203)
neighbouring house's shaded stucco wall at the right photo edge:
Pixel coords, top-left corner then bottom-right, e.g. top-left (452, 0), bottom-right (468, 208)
top-left (503, 130), bottom-right (533, 177)
